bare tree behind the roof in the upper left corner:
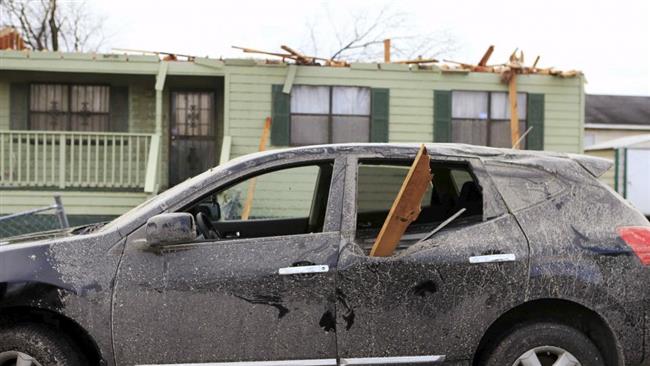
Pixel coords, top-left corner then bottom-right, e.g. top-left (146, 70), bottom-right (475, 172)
top-left (0, 0), bottom-right (106, 51)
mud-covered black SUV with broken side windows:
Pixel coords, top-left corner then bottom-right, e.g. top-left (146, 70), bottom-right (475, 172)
top-left (0, 144), bottom-right (650, 366)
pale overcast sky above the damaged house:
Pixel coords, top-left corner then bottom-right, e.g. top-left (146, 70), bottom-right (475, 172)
top-left (92, 0), bottom-right (650, 95)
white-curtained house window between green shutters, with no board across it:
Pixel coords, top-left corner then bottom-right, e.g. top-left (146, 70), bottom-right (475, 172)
top-left (290, 85), bottom-right (370, 145)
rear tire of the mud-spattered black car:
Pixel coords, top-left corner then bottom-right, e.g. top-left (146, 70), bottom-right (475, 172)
top-left (481, 323), bottom-right (605, 366)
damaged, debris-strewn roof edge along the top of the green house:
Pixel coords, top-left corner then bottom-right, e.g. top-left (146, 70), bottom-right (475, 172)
top-left (0, 49), bottom-right (583, 78)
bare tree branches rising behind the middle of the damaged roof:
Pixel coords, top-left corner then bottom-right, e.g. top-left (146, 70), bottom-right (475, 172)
top-left (301, 5), bottom-right (458, 61)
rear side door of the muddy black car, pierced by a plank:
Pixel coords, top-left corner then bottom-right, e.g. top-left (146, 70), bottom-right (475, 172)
top-left (336, 152), bottom-right (528, 365)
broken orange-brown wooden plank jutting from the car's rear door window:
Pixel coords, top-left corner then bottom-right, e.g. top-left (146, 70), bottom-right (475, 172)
top-left (370, 145), bottom-right (432, 257)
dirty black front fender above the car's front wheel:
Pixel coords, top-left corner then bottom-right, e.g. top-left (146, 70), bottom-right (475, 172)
top-left (0, 233), bottom-right (124, 364)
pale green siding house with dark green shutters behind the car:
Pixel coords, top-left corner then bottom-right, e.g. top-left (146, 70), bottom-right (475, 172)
top-left (0, 51), bottom-right (584, 222)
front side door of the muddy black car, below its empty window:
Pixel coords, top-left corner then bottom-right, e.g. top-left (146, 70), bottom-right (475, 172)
top-left (113, 160), bottom-right (345, 365)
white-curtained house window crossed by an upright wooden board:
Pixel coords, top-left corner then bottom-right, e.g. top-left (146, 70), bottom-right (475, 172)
top-left (451, 91), bottom-right (527, 149)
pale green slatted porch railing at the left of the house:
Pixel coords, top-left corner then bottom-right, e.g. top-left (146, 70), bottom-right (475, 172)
top-left (0, 130), bottom-right (159, 190)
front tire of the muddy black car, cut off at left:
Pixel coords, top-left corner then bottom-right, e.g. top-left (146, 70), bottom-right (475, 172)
top-left (0, 324), bottom-right (85, 366)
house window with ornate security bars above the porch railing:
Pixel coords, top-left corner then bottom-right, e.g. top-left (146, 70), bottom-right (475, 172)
top-left (29, 84), bottom-right (110, 131)
